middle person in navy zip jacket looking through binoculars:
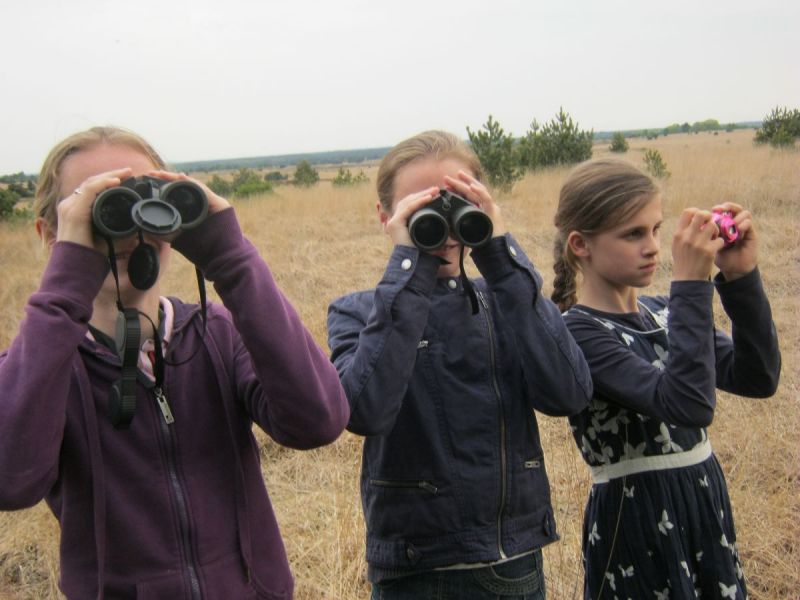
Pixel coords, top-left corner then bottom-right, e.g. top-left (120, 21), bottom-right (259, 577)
top-left (328, 131), bottom-right (591, 600)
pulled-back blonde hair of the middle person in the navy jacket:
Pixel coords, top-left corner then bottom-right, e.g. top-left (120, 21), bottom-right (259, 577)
top-left (377, 130), bottom-right (483, 212)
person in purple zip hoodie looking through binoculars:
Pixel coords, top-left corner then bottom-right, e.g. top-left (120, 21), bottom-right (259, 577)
top-left (0, 127), bottom-right (349, 599)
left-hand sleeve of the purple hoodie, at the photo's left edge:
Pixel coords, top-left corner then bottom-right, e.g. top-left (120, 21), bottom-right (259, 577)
top-left (0, 242), bottom-right (109, 510)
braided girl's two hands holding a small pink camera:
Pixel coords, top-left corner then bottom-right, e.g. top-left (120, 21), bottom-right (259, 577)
top-left (672, 202), bottom-right (758, 281)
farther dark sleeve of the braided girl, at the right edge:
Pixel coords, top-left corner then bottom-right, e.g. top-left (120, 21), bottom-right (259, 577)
top-left (714, 269), bottom-right (781, 398)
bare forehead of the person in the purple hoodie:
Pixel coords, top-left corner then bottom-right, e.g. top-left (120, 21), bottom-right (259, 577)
top-left (59, 144), bottom-right (156, 196)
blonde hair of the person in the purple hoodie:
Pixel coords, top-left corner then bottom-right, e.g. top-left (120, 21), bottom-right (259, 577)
top-left (33, 126), bottom-right (165, 229)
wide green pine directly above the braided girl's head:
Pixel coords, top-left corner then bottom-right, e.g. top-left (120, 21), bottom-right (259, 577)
top-left (519, 108), bottom-right (594, 169)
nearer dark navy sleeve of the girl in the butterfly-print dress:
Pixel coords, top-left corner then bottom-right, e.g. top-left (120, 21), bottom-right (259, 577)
top-left (567, 281), bottom-right (716, 427)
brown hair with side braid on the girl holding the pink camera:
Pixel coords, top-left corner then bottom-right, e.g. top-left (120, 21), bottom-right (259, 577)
top-left (550, 158), bottom-right (660, 311)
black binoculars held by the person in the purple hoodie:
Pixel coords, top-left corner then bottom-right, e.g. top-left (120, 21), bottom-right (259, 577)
top-left (92, 176), bottom-right (208, 238)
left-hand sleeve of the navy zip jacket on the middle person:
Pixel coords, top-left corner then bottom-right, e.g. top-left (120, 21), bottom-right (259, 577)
top-left (328, 246), bottom-right (440, 435)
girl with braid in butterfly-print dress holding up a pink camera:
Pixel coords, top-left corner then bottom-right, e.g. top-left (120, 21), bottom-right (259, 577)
top-left (552, 160), bottom-right (780, 600)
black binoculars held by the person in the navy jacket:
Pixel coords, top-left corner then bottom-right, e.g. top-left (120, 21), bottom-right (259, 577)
top-left (408, 189), bottom-right (492, 250)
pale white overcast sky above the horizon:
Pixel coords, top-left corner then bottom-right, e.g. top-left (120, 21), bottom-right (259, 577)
top-left (0, 0), bottom-right (800, 174)
